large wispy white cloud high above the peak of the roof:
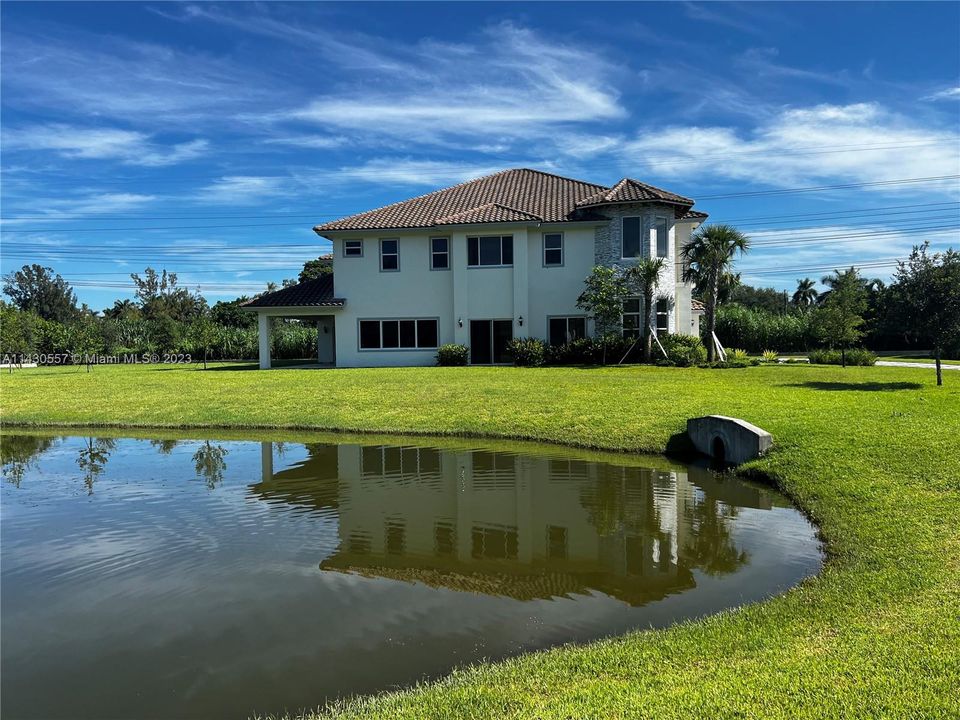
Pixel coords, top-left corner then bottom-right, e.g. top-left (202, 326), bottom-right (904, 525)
top-left (286, 24), bottom-right (626, 143)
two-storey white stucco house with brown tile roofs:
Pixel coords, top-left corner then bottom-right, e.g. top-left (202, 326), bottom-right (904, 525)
top-left (245, 169), bottom-right (707, 368)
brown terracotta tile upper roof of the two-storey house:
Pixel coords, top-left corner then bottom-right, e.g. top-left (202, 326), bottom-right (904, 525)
top-left (314, 168), bottom-right (693, 235)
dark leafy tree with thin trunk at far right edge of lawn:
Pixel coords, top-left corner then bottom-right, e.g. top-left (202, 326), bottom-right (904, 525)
top-left (891, 242), bottom-right (960, 385)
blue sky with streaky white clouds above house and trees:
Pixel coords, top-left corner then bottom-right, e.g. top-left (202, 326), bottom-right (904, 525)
top-left (0, 2), bottom-right (960, 309)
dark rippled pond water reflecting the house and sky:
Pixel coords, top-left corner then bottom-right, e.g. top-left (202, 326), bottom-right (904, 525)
top-left (0, 433), bottom-right (822, 720)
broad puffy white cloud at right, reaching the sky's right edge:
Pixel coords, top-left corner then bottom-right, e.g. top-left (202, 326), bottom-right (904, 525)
top-left (624, 103), bottom-right (960, 194)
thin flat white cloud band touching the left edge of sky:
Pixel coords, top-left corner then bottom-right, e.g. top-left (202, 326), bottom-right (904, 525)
top-left (3, 123), bottom-right (209, 167)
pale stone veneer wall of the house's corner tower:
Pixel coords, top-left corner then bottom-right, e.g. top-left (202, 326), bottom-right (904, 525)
top-left (593, 203), bottom-right (690, 333)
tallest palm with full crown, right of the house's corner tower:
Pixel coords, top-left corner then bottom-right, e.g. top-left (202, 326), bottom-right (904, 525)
top-left (682, 225), bottom-right (750, 362)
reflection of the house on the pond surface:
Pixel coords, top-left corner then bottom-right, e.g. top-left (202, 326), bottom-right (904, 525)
top-left (252, 443), bottom-right (772, 605)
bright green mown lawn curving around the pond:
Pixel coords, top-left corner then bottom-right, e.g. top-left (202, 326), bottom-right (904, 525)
top-left (0, 365), bottom-right (960, 719)
